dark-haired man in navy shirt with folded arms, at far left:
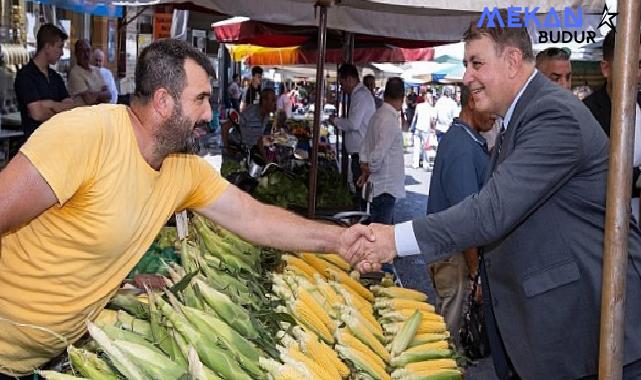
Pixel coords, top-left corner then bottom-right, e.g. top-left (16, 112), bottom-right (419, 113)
top-left (15, 24), bottom-right (75, 139)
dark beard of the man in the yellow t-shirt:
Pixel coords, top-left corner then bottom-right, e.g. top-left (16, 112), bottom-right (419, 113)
top-left (154, 99), bottom-right (199, 157)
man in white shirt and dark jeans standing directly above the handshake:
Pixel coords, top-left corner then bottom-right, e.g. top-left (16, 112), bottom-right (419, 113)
top-left (359, 77), bottom-right (405, 224)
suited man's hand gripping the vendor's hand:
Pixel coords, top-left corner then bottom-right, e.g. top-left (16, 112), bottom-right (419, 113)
top-left (356, 224), bottom-right (396, 272)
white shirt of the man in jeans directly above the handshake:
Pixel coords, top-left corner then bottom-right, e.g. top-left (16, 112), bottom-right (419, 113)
top-left (360, 103), bottom-right (405, 201)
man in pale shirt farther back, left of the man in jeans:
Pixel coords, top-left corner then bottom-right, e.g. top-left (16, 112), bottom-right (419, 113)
top-left (329, 63), bottom-right (376, 193)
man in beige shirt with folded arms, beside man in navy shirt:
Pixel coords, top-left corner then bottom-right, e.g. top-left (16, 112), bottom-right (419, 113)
top-left (69, 39), bottom-right (111, 105)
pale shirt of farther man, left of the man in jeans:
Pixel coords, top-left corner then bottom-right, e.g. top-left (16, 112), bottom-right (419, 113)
top-left (334, 83), bottom-right (376, 154)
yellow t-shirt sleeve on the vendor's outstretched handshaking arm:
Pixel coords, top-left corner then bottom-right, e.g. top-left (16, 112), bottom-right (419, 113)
top-left (177, 156), bottom-right (229, 211)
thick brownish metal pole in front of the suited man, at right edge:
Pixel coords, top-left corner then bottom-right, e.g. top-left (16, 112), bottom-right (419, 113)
top-left (599, 0), bottom-right (641, 380)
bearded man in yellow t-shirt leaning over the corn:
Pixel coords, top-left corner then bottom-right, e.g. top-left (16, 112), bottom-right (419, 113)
top-left (0, 40), bottom-right (373, 377)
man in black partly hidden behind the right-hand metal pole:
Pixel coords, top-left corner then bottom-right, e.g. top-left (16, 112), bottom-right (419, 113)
top-left (583, 30), bottom-right (641, 205)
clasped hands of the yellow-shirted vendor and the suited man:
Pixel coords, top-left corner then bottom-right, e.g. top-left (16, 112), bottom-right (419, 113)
top-left (338, 224), bottom-right (396, 272)
